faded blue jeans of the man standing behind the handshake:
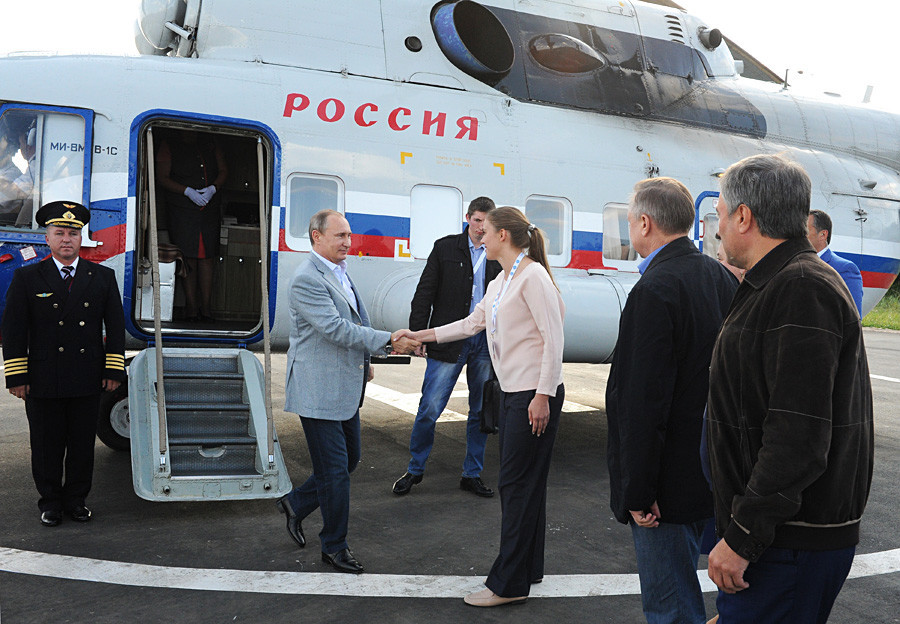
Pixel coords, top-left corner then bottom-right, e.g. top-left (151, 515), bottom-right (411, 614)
top-left (406, 332), bottom-right (491, 477)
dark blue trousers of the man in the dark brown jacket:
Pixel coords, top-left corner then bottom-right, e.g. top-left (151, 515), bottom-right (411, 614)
top-left (716, 546), bottom-right (856, 624)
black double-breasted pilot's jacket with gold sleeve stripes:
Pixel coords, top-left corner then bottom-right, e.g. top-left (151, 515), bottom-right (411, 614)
top-left (2, 258), bottom-right (125, 398)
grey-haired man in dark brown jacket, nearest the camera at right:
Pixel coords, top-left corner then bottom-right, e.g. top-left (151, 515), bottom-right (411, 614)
top-left (708, 156), bottom-right (874, 624)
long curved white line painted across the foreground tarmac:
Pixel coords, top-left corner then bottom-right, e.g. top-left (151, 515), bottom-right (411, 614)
top-left (0, 548), bottom-right (900, 598)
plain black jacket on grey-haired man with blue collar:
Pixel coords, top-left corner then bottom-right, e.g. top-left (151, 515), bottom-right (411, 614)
top-left (606, 237), bottom-right (737, 524)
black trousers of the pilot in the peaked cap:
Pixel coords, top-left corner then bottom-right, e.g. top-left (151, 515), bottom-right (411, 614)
top-left (25, 394), bottom-right (100, 511)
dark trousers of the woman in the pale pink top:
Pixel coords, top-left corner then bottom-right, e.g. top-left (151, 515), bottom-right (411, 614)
top-left (484, 384), bottom-right (565, 598)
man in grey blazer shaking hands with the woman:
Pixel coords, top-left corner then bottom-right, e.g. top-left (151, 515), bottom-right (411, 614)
top-left (278, 210), bottom-right (419, 574)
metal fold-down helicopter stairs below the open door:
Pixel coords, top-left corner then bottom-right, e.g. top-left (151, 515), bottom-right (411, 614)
top-left (128, 347), bottom-right (291, 501)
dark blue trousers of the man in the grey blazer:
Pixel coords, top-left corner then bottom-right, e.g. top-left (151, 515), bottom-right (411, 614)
top-left (288, 411), bottom-right (360, 554)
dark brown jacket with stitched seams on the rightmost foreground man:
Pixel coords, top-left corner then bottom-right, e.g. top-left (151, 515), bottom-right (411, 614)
top-left (708, 238), bottom-right (874, 561)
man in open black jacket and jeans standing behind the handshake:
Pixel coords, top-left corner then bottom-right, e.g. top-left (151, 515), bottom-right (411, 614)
top-left (393, 197), bottom-right (501, 497)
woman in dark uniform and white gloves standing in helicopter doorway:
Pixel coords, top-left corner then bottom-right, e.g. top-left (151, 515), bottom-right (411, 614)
top-left (156, 131), bottom-right (228, 322)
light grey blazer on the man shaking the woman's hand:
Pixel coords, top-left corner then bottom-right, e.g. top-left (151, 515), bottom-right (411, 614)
top-left (284, 254), bottom-right (391, 420)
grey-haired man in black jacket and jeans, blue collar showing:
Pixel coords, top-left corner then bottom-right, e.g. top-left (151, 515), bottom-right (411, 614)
top-left (606, 178), bottom-right (737, 624)
